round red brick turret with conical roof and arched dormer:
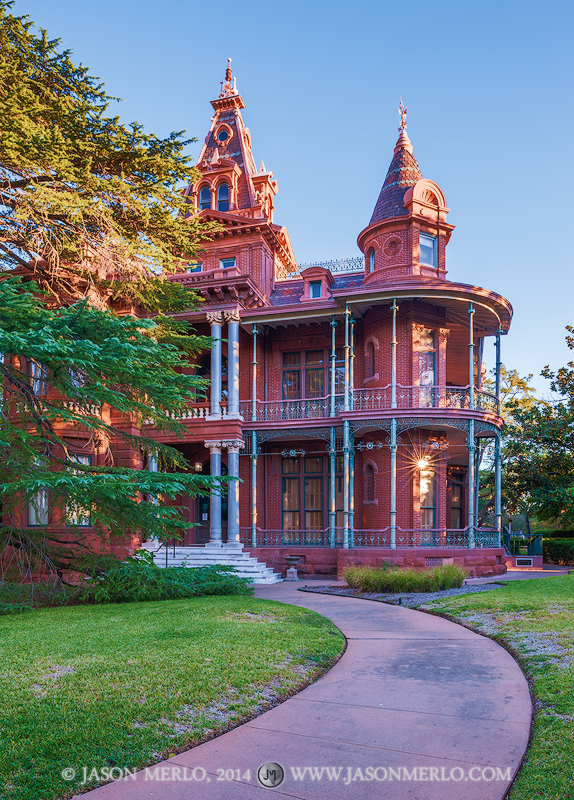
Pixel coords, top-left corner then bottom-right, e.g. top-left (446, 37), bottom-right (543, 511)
top-left (357, 100), bottom-right (454, 283)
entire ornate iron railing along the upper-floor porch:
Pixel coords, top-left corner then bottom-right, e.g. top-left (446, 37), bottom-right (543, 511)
top-left (239, 384), bottom-right (500, 422)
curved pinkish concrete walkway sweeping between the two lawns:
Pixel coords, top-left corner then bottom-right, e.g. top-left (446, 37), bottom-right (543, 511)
top-left (81, 583), bottom-right (532, 800)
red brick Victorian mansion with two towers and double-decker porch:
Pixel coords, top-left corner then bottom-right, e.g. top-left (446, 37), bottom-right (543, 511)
top-left (144, 61), bottom-right (512, 575)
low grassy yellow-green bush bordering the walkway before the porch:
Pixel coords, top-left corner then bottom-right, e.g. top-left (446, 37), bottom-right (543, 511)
top-left (344, 563), bottom-right (467, 594)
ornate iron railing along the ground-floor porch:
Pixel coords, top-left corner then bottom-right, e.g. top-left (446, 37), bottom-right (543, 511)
top-left (240, 527), bottom-right (500, 549)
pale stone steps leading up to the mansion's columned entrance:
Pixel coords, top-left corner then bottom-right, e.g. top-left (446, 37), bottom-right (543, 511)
top-left (140, 542), bottom-right (283, 584)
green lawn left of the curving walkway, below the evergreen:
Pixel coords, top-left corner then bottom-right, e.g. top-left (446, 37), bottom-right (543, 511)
top-left (0, 596), bottom-right (344, 800)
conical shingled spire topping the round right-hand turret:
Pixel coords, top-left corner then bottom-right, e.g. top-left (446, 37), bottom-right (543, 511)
top-left (369, 97), bottom-right (423, 225)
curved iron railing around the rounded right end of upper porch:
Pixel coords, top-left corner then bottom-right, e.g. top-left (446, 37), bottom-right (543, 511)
top-left (352, 384), bottom-right (499, 414)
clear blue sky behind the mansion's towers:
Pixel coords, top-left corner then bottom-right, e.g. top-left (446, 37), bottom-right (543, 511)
top-left (15, 0), bottom-right (574, 392)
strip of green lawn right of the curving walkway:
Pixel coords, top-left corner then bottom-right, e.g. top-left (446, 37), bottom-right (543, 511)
top-left (423, 575), bottom-right (574, 800)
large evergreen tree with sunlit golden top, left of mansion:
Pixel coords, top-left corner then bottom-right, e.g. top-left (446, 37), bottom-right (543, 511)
top-left (0, 6), bottom-right (221, 574)
